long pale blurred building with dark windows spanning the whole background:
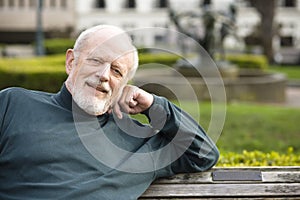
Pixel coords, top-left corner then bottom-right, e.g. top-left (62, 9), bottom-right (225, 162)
top-left (0, 0), bottom-right (300, 60)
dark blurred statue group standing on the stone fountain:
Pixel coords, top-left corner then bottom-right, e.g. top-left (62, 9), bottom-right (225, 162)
top-left (169, 5), bottom-right (236, 58)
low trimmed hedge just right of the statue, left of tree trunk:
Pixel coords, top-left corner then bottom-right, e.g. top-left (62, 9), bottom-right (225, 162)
top-left (226, 54), bottom-right (268, 70)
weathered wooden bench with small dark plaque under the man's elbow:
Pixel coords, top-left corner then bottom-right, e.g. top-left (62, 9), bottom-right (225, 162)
top-left (140, 167), bottom-right (300, 199)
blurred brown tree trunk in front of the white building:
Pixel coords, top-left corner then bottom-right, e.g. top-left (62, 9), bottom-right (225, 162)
top-left (248, 0), bottom-right (277, 62)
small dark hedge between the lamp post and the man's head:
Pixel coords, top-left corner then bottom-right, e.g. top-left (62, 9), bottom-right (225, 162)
top-left (44, 38), bottom-right (75, 55)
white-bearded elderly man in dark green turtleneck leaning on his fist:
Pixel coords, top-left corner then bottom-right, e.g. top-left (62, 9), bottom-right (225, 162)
top-left (0, 25), bottom-right (219, 200)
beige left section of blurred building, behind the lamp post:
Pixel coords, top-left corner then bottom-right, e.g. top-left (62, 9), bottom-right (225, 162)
top-left (0, 0), bottom-right (76, 43)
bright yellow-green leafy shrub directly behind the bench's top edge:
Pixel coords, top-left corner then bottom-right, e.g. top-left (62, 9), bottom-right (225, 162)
top-left (217, 147), bottom-right (300, 167)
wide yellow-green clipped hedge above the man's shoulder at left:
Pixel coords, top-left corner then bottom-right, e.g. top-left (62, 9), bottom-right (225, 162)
top-left (0, 55), bottom-right (67, 92)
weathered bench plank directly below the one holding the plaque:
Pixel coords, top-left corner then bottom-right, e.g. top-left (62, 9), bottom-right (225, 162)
top-left (143, 183), bottom-right (300, 198)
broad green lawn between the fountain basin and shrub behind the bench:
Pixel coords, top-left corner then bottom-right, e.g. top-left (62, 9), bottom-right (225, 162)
top-left (133, 102), bottom-right (300, 153)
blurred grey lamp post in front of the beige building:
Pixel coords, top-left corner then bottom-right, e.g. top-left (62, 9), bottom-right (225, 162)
top-left (36, 0), bottom-right (45, 56)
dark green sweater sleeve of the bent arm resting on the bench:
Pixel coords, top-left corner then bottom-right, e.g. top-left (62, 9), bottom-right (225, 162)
top-left (144, 96), bottom-right (219, 177)
